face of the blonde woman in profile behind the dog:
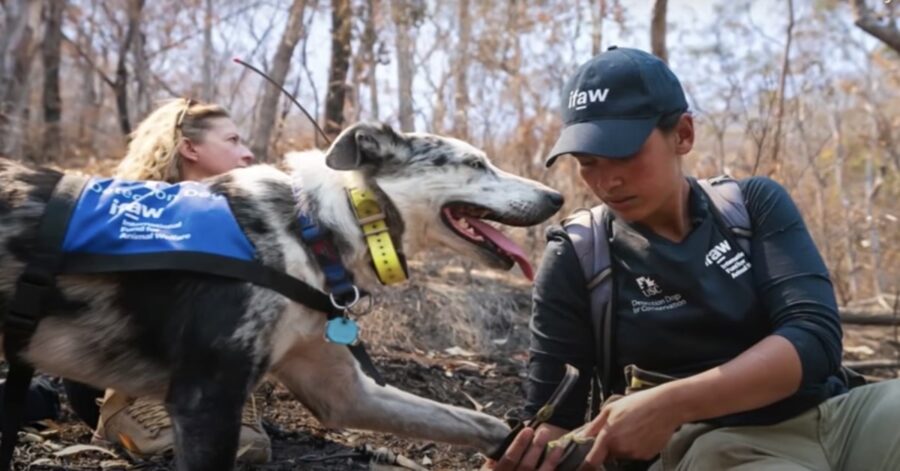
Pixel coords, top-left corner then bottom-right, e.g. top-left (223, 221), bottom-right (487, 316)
top-left (181, 118), bottom-right (254, 180)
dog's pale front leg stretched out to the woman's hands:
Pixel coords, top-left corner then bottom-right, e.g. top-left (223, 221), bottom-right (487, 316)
top-left (273, 342), bottom-right (509, 453)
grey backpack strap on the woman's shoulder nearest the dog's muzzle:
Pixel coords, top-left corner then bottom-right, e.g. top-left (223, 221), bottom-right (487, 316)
top-left (563, 205), bottom-right (614, 416)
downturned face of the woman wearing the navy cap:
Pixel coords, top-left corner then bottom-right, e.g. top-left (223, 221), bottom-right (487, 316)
top-left (574, 115), bottom-right (693, 222)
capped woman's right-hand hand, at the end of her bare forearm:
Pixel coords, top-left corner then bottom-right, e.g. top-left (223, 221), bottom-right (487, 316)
top-left (579, 386), bottom-right (684, 471)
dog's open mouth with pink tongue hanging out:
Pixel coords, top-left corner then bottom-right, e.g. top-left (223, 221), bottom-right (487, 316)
top-left (441, 203), bottom-right (534, 280)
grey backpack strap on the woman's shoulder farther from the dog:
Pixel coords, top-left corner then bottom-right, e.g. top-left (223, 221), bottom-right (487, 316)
top-left (697, 175), bottom-right (753, 254)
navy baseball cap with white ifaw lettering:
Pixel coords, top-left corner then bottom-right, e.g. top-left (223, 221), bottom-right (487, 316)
top-left (546, 46), bottom-right (688, 167)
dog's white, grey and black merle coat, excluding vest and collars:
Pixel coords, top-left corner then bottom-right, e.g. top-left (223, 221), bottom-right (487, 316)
top-left (0, 124), bottom-right (562, 471)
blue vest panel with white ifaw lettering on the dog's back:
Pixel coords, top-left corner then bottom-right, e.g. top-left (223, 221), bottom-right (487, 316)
top-left (63, 178), bottom-right (255, 261)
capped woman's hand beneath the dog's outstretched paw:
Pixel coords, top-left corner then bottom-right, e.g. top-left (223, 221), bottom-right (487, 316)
top-left (481, 424), bottom-right (568, 471)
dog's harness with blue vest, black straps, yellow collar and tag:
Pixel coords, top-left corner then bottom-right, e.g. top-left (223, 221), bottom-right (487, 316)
top-left (0, 175), bottom-right (406, 471)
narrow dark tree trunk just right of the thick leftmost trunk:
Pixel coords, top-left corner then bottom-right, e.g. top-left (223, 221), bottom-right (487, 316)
top-left (41, 0), bottom-right (66, 162)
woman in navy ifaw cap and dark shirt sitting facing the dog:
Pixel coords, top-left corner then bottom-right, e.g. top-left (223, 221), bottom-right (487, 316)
top-left (486, 48), bottom-right (900, 470)
